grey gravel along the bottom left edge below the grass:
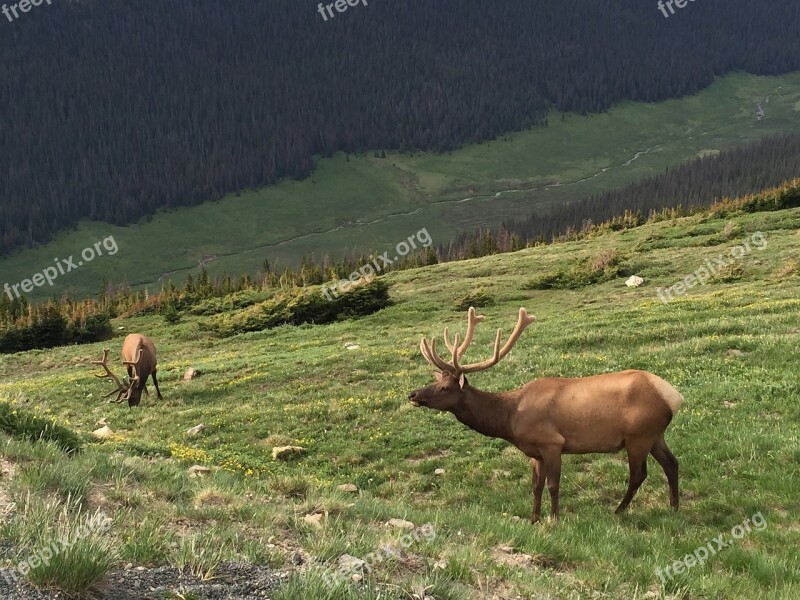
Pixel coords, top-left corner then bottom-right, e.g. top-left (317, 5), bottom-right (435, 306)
top-left (0, 563), bottom-right (289, 600)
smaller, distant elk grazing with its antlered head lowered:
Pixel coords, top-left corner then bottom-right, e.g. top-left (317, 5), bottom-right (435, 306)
top-left (92, 333), bottom-right (163, 406)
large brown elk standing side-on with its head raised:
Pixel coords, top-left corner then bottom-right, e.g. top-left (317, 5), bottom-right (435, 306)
top-left (408, 308), bottom-right (683, 523)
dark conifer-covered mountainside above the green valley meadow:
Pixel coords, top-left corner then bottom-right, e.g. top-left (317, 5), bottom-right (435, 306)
top-left (0, 0), bottom-right (800, 253)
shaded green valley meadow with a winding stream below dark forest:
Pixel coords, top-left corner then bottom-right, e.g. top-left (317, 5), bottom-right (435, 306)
top-left (0, 73), bottom-right (800, 298)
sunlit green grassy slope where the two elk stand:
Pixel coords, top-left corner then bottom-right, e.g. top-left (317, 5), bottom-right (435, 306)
top-left (0, 209), bottom-right (800, 600)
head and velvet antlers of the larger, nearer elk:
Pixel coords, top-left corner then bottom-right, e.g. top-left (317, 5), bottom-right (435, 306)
top-left (408, 307), bottom-right (536, 412)
